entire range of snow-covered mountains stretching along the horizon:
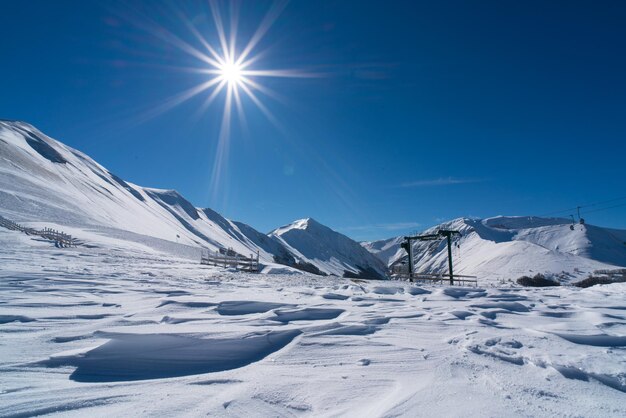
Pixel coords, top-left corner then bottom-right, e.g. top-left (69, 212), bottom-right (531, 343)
top-left (0, 121), bottom-right (626, 280)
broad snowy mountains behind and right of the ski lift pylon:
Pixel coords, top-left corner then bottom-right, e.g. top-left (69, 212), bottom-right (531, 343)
top-left (361, 216), bottom-right (626, 281)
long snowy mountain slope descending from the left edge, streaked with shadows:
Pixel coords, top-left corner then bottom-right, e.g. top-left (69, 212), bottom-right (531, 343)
top-left (0, 122), bottom-right (273, 261)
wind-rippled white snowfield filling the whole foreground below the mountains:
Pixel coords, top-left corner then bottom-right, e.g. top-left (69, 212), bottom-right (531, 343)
top-left (0, 231), bottom-right (626, 417)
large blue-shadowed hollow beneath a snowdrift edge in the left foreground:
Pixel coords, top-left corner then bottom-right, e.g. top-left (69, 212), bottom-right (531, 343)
top-left (40, 330), bottom-right (300, 382)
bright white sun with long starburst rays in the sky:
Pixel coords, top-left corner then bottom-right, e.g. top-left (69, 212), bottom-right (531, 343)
top-left (138, 0), bottom-right (316, 201)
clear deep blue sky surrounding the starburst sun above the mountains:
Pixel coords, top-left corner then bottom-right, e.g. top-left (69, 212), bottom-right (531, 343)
top-left (0, 0), bottom-right (626, 239)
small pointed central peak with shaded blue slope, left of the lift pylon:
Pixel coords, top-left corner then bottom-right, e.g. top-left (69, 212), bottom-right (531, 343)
top-left (269, 218), bottom-right (386, 278)
